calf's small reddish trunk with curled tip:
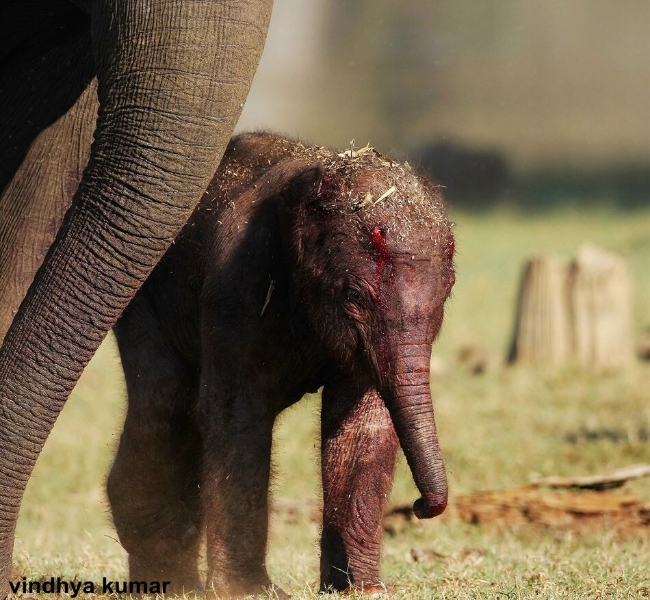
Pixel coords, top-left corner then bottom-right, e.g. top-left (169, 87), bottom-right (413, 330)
top-left (381, 344), bottom-right (447, 519)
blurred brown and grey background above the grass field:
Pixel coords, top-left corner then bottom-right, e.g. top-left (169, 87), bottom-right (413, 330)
top-left (240, 0), bottom-right (650, 209)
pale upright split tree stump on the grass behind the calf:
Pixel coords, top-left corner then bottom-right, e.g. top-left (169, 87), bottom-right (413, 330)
top-left (509, 246), bottom-right (634, 369)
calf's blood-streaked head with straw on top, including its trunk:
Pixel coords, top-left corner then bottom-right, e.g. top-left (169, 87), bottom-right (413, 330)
top-left (281, 153), bottom-right (454, 518)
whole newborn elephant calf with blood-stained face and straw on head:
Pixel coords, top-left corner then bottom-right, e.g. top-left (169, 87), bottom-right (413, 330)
top-left (108, 134), bottom-right (454, 597)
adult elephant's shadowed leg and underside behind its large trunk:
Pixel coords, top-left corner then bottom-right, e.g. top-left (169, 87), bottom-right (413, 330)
top-left (0, 0), bottom-right (97, 343)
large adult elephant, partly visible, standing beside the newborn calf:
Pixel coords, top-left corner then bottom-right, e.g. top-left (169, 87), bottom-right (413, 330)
top-left (0, 0), bottom-right (272, 598)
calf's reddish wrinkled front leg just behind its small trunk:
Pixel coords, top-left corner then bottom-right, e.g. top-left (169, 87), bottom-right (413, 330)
top-left (321, 380), bottom-right (398, 593)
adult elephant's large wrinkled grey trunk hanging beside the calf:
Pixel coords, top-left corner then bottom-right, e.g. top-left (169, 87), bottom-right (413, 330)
top-left (0, 0), bottom-right (271, 597)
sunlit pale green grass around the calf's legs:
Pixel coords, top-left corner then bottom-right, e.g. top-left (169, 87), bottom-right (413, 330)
top-left (15, 209), bottom-right (650, 600)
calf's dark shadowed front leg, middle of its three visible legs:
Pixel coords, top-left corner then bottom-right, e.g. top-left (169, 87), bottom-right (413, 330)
top-left (201, 384), bottom-right (280, 598)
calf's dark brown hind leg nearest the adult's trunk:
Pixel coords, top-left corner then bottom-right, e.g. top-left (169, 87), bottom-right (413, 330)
top-left (108, 302), bottom-right (202, 592)
